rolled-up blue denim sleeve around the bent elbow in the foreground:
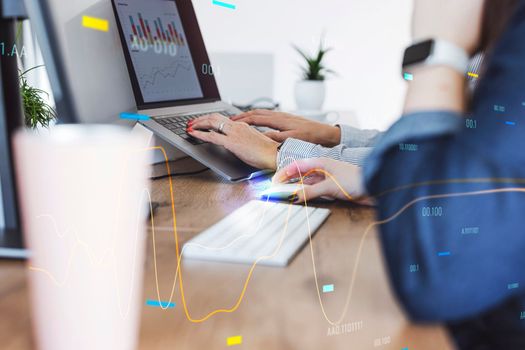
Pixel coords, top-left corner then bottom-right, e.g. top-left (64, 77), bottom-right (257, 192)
top-left (364, 111), bottom-right (525, 322)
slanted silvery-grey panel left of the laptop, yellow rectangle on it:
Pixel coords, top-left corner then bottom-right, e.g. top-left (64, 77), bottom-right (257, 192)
top-left (25, 0), bottom-right (135, 123)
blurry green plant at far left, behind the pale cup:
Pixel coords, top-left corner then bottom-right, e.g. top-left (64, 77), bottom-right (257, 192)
top-left (19, 66), bottom-right (57, 129)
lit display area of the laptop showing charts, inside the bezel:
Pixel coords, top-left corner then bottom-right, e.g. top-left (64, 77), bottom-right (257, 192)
top-left (117, 0), bottom-right (203, 102)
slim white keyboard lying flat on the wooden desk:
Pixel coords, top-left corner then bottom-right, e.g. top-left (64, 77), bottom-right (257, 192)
top-left (183, 200), bottom-right (330, 266)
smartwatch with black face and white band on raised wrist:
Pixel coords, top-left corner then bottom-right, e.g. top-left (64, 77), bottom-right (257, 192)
top-left (401, 39), bottom-right (470, 76)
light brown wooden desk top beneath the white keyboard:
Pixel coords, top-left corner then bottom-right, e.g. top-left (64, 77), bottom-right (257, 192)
top-left (0, 165), bottom-right (452, 350)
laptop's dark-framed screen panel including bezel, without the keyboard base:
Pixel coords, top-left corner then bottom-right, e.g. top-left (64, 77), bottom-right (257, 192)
top-left (113, 0), bottom-right (219, 107)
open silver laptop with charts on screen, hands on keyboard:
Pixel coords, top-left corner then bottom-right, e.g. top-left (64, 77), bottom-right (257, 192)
top-left (112, 0), bottom-right (268, 181)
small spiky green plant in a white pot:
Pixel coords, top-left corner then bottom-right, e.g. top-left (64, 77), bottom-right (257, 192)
top-left (294, 40), bottom-right (334, 111)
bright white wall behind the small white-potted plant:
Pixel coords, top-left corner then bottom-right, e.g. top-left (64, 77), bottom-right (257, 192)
top-left (193, 0), bottom-right (412, 129)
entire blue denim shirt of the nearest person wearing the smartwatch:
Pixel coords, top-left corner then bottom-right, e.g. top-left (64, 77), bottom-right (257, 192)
top-left (364, 1), bottom-right (525, 322)
